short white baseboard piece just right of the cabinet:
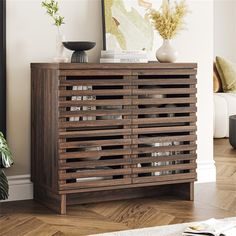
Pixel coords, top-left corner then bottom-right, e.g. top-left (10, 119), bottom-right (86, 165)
top-left (197, 160), bottom-right (216, 183)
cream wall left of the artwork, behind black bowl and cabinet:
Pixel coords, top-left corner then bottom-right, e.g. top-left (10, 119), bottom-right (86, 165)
top-left (7, 0), bottom-right (102, 175)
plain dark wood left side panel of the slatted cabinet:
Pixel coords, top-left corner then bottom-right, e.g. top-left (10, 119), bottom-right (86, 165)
top-left (31, 69), bottom-right (58, 199)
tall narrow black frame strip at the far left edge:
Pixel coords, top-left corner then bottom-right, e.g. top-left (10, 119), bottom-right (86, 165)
top-left (0, 0), bottom-right (6, 135)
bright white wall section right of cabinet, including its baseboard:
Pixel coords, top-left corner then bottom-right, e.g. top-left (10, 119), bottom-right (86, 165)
top-left (176, 0), bottom-right (215, 182)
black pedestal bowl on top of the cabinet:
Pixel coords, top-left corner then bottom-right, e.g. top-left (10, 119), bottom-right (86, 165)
top-left (63, 41), bottom-right (96, 63)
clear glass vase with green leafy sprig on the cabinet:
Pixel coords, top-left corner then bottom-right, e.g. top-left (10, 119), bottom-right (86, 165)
top-left (42, 0), bottom-right (68, 62)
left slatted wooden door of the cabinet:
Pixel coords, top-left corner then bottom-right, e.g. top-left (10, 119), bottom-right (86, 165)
top-left (59, 71), bottom-right (131, 192)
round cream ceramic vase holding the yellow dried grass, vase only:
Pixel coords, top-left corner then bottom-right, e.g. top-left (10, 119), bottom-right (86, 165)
top-left (156, 39), bottom-right (178, 63)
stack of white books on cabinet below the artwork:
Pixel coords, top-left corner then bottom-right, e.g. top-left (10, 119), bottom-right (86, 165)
top-left (100, 50), bottom-right (148, 63)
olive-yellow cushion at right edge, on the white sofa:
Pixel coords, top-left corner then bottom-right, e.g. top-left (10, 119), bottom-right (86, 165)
top-left (216, 57), bottom-right (236, 93)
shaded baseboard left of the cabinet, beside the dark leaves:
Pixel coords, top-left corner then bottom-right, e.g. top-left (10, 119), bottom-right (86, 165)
top-left (1, 175), bottom-right (33, 202)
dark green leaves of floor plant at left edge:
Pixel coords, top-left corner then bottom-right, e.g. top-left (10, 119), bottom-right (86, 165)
top-left (0, 132), bottom-right (13, 200)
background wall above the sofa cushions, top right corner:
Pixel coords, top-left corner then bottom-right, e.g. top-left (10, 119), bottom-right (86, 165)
top-left (214, 0), bottom-right (236, 62)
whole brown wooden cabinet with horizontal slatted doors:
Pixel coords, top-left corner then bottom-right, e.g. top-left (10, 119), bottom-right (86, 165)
top-left (31, 63), bottom-right (197, 214)
